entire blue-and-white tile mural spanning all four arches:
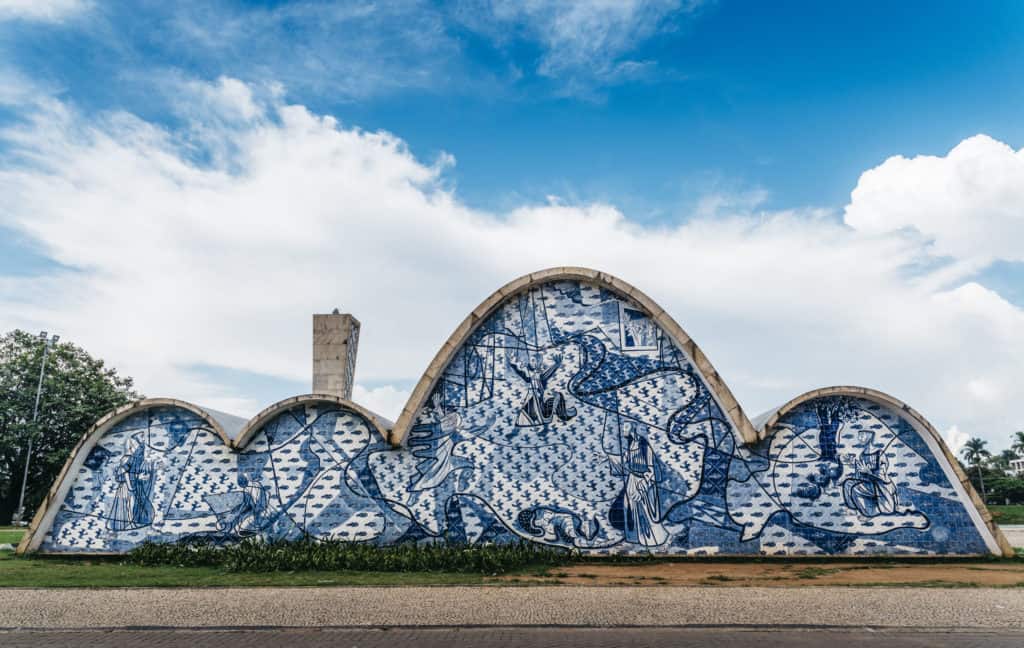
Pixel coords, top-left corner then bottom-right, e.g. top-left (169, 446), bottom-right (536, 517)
top-left (28, 280), bottom-right (999, 555)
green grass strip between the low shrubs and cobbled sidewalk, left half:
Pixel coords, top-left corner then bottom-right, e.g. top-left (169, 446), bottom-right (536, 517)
top-left (0, 552), bottom-right (494, 589)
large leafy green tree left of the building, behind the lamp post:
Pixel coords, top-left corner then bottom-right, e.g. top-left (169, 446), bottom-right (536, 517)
top-left (0, 331), bottom-right (141, 524)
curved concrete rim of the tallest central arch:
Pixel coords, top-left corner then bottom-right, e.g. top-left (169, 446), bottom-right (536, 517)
top-left (388, 266), bottom-right (758, 445)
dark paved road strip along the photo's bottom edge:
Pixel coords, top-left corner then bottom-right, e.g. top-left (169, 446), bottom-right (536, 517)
top-left (0, 628), bottom-right (1024, 648)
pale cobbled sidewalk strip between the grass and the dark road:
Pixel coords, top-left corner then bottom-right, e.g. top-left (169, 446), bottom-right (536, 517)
top-left (0, 587), bottom-right (1024, 630)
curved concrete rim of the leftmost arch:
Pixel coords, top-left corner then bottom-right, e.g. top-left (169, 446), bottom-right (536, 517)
top-left (17, 398), bottom-right (231, 554)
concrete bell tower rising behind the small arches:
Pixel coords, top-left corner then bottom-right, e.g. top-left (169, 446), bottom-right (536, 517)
top-left (313, 308), bottom-right (359, 400)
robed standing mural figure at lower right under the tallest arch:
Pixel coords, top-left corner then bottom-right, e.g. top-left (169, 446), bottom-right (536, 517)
top-left (608, 421), bottom-right (670, 547)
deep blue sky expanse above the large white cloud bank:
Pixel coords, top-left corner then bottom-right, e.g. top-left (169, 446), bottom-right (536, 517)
top-left (8, 2), bottom-right (1024, 221)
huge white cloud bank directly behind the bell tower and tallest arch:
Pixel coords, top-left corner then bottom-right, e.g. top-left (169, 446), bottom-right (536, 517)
top-left (0, 80), bottom-right (1024, 444)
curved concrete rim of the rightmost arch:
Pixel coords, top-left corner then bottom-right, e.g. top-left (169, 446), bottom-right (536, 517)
top-left (758, 385), bottom-right (1015, 558)
